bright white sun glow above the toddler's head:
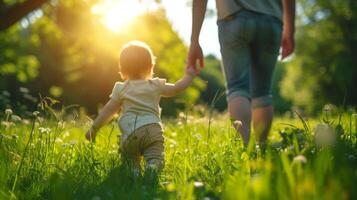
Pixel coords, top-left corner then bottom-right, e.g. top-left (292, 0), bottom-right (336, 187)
top-left (92, 0), bottom-right (155, 32)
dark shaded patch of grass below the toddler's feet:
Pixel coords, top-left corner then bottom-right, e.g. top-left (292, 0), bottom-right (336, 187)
top-left (41, 166), bottom-right (175, 200)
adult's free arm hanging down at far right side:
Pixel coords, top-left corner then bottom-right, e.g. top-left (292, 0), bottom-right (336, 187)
top-left (281, 0), bottom-right (295, 59)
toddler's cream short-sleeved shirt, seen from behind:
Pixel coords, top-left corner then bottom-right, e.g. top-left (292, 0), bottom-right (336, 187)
top-left (110, 78), bottom-right (166, 139)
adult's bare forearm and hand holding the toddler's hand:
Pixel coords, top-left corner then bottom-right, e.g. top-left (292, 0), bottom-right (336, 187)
top-left (187, 0), bottom-right (207, 71)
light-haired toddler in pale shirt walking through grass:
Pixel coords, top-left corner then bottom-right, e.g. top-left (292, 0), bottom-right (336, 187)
top-left (86, 41), bottom-right (196, 175)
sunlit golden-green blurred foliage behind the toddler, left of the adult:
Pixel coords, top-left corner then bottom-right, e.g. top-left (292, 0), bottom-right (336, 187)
top-left (0, 0), bottom-right (205, 115)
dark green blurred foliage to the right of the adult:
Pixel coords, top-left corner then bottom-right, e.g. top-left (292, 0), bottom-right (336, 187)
top-left (281, 0), bottom-right (357, 112)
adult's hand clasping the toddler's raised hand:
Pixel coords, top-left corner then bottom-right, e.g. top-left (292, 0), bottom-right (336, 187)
top-left (187, 43), bottom-right (204, 74)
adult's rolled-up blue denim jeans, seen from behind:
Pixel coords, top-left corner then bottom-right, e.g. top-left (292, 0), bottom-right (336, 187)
top-left (217, 10), bottom-right (282, 107)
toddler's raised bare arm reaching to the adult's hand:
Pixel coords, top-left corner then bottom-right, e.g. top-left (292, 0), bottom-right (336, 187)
top-left (162, 67), bottom-right (196, 97)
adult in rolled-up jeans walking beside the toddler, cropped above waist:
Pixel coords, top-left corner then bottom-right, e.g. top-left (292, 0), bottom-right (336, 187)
top-left (188, 0), bottom-right (295, 144)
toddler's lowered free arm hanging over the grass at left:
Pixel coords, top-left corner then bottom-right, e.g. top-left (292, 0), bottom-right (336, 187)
top-left (86, 99), bottom-right (121, 141)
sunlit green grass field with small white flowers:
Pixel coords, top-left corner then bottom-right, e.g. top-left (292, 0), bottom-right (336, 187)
top-left (0, 106), bottom-right (357, 200)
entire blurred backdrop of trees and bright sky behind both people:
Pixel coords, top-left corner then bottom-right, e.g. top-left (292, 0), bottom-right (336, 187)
top-left (0, 0), bottom-right (357, 116)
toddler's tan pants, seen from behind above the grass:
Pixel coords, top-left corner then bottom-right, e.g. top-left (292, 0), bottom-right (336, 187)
top-left (120, 123), bottom-right (164, 171)
